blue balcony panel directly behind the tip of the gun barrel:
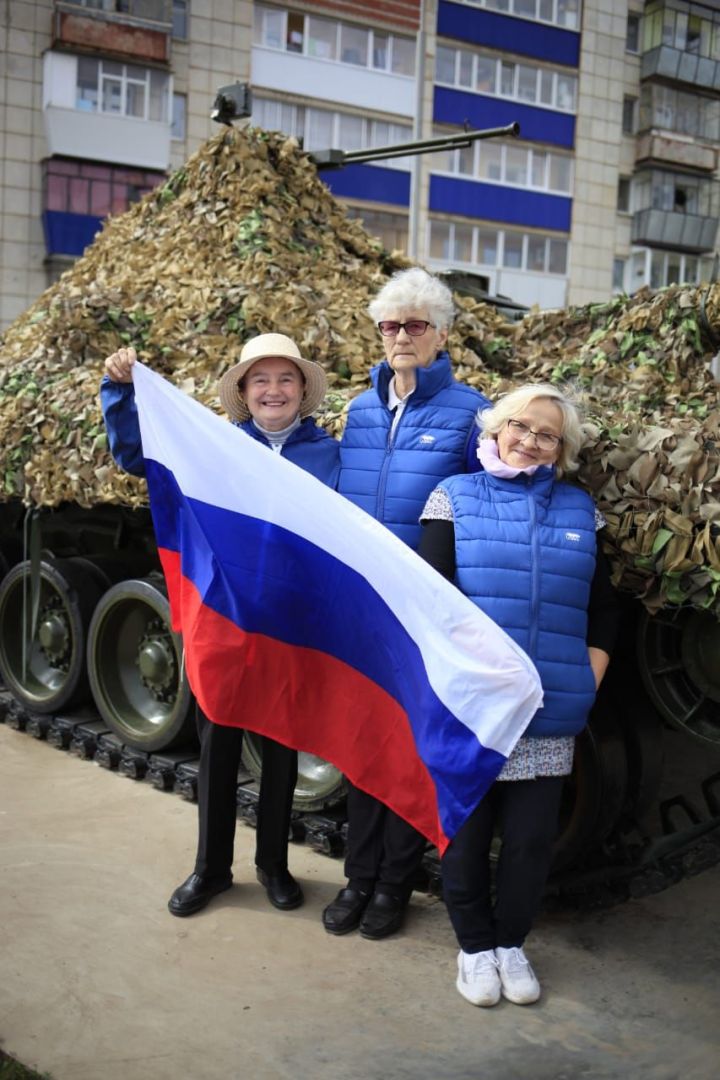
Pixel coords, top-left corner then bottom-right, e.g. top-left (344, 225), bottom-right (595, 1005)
top-left (433, 86), bottom-right (575, 149)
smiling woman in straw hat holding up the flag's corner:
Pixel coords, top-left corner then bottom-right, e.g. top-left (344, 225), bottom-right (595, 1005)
top-left (100, 334), bottom-right (338, 916)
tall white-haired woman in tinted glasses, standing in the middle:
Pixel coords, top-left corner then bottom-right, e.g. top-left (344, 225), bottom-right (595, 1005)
top-left (323, 267), bottom-right (489, 940)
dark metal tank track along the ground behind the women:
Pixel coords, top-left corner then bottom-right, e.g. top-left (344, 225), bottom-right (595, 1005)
top-left (0, 690), bottom-right (720, 910)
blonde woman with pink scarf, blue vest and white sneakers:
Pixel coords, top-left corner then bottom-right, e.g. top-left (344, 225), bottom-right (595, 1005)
top-left (420, 383), bottom-right (619, 1005)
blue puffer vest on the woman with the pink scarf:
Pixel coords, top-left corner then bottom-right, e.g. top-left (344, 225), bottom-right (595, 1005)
top-left (441, 468), bottom-right (596, 735)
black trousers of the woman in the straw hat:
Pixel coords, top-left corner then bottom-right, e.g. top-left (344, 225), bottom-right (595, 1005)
top-left (195, 706), bottom-right (298, 877)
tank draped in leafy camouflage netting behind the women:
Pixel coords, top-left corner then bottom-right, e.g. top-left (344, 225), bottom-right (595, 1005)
top-left (0, 127), bottom-right (720, 892)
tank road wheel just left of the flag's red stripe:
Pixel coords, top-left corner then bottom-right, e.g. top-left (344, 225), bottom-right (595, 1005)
top-left (87, 578), bottom-right (194, 753)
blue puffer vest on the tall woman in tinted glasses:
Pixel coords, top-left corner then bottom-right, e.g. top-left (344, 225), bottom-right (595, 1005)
top-left (338, 352), bottom-right (490, 549)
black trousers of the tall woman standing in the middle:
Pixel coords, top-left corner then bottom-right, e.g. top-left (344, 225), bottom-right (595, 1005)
top-left (345, 784), bottom-right (427, 900)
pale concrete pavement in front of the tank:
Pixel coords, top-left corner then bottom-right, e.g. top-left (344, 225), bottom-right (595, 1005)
top-left (0, 725), bottom-right (720, 1080)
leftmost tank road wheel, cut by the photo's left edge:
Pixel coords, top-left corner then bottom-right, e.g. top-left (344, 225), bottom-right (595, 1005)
top-left (0, 558), bottom-right (104, 713)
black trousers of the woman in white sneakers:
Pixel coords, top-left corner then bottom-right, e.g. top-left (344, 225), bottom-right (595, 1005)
top-left (443, 777), bottom-right (565, 953)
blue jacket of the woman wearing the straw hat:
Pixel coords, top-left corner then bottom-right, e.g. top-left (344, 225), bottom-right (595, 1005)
top-left (100, 375), bottom-right (340, 487)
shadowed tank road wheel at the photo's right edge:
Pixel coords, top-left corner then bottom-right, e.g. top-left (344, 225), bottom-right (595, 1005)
top-left (638, 609), bottom-right (720, 746)
